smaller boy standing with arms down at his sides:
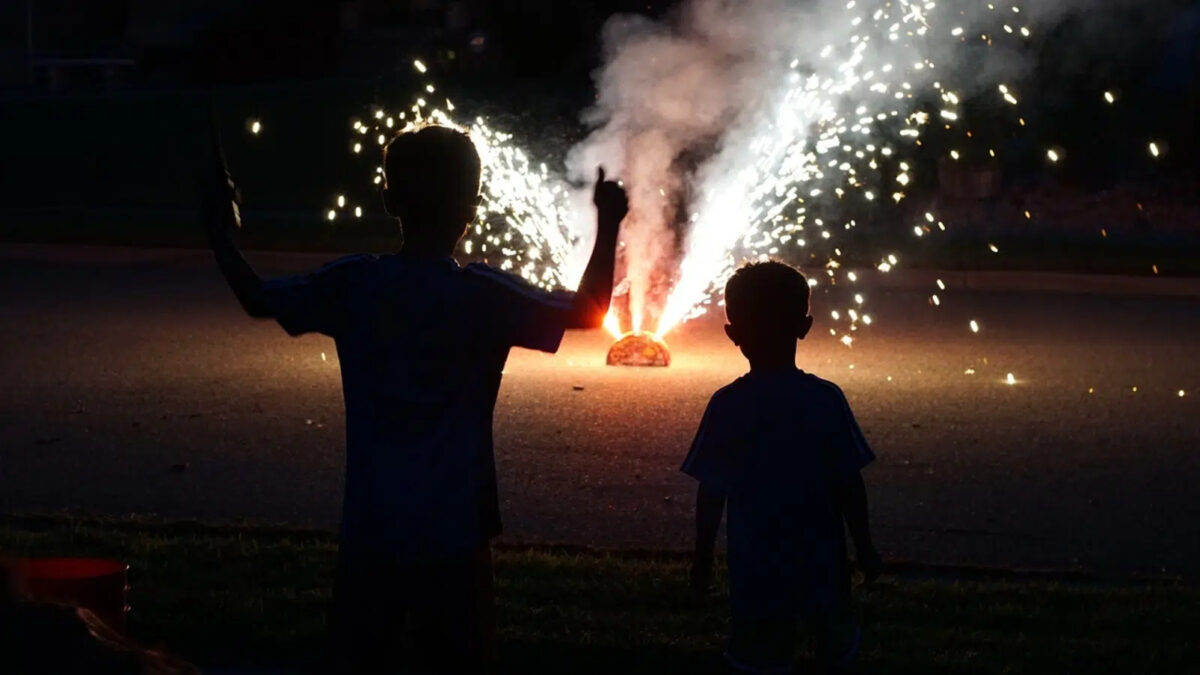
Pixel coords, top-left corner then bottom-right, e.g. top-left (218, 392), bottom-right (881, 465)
top-left (683, 262), bottom-right (881, 674)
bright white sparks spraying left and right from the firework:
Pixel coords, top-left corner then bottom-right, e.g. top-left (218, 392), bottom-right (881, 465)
top-left (328, 0), bottom-right (1132, 355)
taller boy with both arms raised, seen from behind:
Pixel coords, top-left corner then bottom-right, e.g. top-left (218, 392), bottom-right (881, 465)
top-left (205, 126), bottom-right (628, 673)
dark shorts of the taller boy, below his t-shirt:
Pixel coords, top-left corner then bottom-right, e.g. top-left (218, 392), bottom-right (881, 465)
top-left (331, 544), bottom-right (496, 674)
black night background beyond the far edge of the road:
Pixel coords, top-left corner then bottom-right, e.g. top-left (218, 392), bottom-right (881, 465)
top-left (0, 0), bottom-right (1200, 260)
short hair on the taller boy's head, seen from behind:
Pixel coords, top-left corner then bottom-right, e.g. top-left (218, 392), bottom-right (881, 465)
top-left (383, 125), bottom-right (481, 220)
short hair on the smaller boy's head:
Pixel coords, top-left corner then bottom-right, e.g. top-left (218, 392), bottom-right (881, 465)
top-left (725, 261), bottom-right (810, 328)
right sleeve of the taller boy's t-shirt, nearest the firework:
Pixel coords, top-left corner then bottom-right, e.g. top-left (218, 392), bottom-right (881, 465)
top-left (467, 263), bottom-right (575, 353)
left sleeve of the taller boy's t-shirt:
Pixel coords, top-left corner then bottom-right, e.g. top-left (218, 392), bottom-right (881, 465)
top-left (263, 256), bottom-right (374, 338)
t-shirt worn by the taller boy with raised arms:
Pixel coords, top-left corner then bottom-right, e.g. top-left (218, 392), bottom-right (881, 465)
top-left (265, 256), bottom-right (574, 561)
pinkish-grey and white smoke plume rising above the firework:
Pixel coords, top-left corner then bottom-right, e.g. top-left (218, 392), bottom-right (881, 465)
top-left (568, 0), bottom-right (1171, 330)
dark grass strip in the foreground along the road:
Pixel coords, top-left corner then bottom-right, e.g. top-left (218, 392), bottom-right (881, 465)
top-left (0, 516), bottom-right (1200, 674)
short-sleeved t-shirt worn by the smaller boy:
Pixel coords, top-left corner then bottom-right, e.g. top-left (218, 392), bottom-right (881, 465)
top-left (683, 369), bottom-right (875, 616)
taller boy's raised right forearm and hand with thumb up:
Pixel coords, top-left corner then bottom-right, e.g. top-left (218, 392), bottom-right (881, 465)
top-left (566, 167), bottom-right (629, 328)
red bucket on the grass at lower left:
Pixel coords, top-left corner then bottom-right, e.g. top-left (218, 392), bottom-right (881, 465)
top-left (16, 557), bottom-right (130, 635)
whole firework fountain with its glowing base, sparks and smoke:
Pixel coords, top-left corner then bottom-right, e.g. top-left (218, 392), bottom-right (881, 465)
top-left (329, 0), bottom-right (1157, 365)
